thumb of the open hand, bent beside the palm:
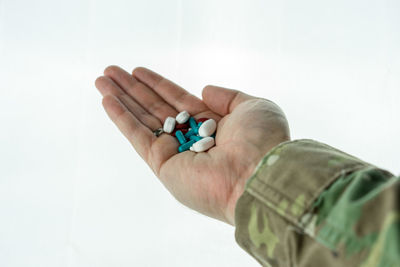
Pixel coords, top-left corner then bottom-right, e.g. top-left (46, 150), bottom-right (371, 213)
top-left (202, 85), bottom-right (255, 116)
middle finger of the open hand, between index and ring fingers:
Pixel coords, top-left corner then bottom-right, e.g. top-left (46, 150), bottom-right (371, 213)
top-left (104, 66), bottom-right (177, 122)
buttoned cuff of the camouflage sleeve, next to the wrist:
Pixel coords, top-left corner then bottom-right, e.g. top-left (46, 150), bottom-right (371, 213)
top-left (235, 140), bottom-right (369, 266)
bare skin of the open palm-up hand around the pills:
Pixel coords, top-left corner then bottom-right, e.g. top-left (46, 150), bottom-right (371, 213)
top-left (95, 66), bottom-right (290, 225)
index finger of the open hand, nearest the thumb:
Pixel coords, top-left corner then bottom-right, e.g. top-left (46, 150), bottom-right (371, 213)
top-left (132, 67), bottom-right (207, 115)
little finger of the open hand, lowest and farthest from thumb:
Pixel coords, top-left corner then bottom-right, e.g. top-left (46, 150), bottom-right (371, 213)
top-left (103, 95), bottom-right (156, 161)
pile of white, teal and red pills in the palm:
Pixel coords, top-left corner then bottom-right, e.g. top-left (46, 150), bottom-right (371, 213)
top-left (163, 111), bottom-right (217, 152)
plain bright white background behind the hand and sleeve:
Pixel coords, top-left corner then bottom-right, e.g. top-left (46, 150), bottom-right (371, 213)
top-left (0, 0), bottom-right (400, 267)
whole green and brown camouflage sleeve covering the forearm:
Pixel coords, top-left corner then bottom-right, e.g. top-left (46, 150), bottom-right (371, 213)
top-left (235, 140), bottom-right (400, 267)
